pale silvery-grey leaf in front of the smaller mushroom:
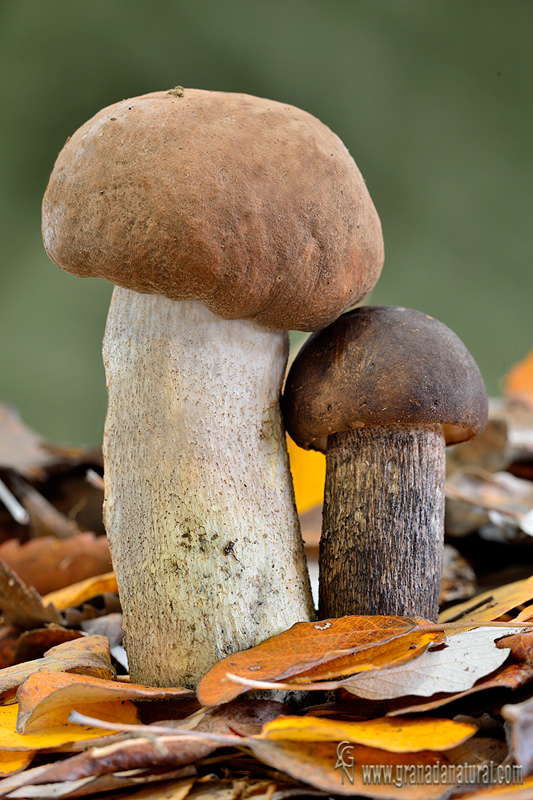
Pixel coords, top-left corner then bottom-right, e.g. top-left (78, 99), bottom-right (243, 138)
top-left (342, 628), bottom-right (513, 700)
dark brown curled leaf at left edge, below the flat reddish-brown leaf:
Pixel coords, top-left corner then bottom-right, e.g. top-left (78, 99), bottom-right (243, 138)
top-left (0, 561), bottom-right (62, 629)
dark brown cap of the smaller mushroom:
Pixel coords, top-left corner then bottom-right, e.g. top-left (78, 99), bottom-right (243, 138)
top-left (282, 306), bottom-right (488, 450)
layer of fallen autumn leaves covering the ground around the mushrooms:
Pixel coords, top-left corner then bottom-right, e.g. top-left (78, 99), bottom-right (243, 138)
top-left (0, 401), bottom-right (533, 800)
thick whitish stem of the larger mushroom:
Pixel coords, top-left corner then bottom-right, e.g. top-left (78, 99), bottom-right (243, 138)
top-left (104, 288), bottom-right (314, 687)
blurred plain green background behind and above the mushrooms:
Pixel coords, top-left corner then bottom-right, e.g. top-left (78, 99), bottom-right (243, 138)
top-left (0, 0), bottom-right (533, 443)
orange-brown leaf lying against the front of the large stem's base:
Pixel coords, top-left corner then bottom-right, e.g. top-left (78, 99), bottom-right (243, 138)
top-left (198, 616), bottom-right (429, 706)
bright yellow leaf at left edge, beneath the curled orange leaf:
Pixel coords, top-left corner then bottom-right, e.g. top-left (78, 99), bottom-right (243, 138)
top-left (0, 700), bottom-right (138, 750)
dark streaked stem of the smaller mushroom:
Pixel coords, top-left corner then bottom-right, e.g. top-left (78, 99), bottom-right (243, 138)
top-left (319, 424), bottom-right (445, 620)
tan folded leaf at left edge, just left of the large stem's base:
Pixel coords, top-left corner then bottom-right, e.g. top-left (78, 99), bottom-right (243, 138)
top-left (0, 636), bottom-right (116, 694)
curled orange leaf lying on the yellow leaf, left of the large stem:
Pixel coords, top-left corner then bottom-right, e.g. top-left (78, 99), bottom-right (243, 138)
top-left (17, 669), bottom-right (194, 733)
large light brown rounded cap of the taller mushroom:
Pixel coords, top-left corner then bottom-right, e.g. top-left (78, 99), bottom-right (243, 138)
top-left (43, 89), bottom-right (383, 330)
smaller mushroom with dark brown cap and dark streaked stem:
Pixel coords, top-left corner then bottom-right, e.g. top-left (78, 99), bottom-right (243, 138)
top-left (282, 306), bottom-right (487, 620)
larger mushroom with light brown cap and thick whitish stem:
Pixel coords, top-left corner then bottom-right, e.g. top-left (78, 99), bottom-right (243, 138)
top-left (43, 88), bottom-right (383, 687)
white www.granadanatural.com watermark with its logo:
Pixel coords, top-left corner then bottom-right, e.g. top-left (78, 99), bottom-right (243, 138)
top-left (335, 742), bottom-right (524, 789)
